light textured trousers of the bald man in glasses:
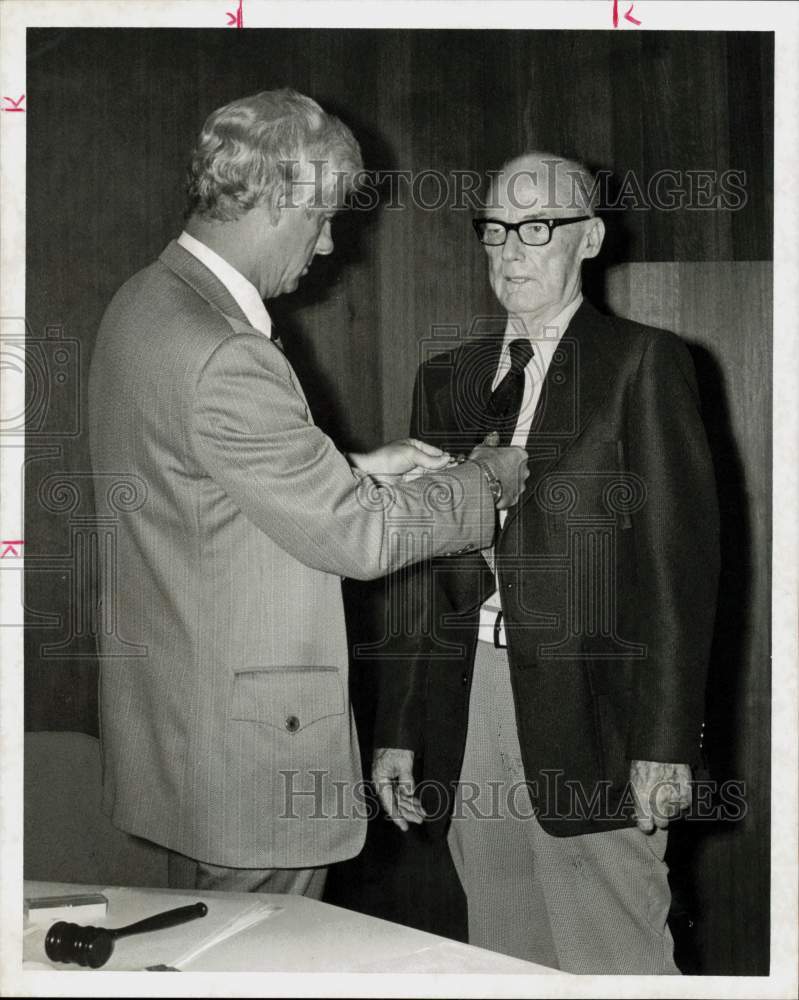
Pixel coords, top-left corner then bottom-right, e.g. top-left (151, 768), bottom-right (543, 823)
top-left (448, 641), bottom-right (679, 975)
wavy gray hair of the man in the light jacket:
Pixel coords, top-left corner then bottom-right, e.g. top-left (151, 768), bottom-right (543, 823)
top-left (186, 88), bottom-right (363, 222)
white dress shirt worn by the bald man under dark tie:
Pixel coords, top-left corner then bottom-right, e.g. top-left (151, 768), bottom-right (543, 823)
top-left (479, 294), bottom-right (583, 643)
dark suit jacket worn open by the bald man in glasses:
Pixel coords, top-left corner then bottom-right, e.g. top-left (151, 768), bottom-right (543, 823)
top-left (375, 303), bottom-right (719, 836)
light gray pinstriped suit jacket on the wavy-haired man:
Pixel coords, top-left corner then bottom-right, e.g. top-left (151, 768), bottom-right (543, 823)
top-left (89, 242), bottom-right (494, 868)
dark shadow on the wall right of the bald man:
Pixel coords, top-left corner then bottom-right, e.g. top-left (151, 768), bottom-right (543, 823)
top-left (666, 342), bottom-right (770, 975)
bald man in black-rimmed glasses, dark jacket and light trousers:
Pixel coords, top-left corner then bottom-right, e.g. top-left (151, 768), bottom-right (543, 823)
top-left (373, 153), bottom-right (719, 974)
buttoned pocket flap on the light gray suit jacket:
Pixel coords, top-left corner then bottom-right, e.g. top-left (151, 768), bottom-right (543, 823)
top-left (231, 667), bottom-right (345, 733)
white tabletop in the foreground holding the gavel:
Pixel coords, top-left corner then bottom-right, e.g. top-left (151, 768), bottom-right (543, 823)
top-left (23, 882), bottom-right (562, 975)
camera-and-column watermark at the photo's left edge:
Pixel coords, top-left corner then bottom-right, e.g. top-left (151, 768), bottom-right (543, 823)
top-left (0, 316), bottom-right (148, 660)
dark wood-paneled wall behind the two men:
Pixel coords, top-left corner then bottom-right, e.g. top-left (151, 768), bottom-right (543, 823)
top-left (25, 29), bottom-right (773, 973)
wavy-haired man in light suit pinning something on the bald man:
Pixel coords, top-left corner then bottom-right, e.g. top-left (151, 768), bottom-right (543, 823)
top-left (89, 91), bottom-right (526, 897)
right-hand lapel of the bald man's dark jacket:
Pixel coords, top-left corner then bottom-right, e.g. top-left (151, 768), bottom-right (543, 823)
top-left (503, 301), bottom-right (618, 531)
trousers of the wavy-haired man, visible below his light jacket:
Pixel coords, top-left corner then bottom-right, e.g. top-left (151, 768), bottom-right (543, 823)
top-left (168, 851), bottom-right (327, 899)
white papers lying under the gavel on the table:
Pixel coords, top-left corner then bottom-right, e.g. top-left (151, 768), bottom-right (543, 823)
top-left (23, 888), bottom-right (282, 972)
